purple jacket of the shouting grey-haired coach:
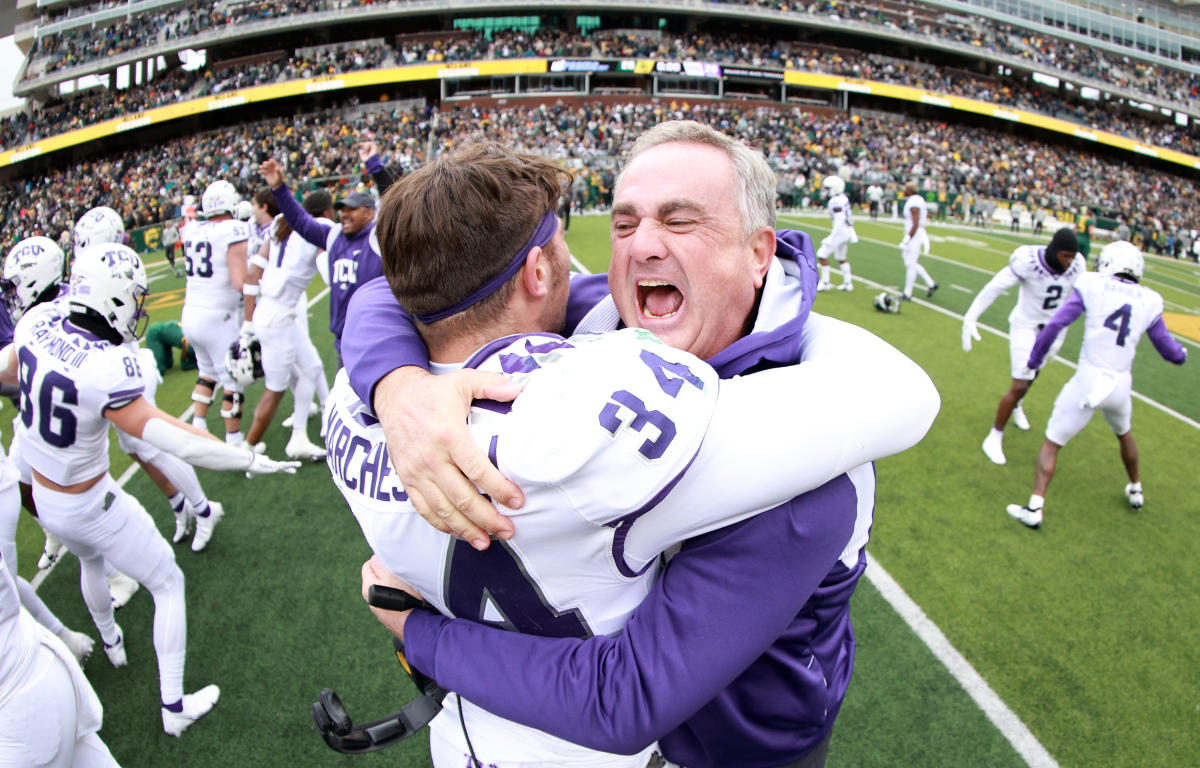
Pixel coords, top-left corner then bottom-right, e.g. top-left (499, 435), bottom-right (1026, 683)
top-left (343, 230), bottom-right (865, 768)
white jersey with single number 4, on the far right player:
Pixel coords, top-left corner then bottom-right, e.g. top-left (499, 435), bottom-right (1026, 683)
top-left (1075, 272), bottom-right (1163, 373)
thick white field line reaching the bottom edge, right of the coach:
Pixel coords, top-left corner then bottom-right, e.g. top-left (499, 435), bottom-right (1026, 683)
top-left (866, 552), bottom-right (1058, 768)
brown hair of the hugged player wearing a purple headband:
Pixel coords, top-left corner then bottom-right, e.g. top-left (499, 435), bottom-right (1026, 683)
top-left (376, 140), bottom-right (570, 341)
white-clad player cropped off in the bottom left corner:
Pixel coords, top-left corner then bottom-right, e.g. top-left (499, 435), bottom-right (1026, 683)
top-left (0, 542), bottom-right (116, 768)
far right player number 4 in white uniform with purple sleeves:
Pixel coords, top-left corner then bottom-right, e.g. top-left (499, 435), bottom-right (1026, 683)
top-left (1008, 240), bottom-right (1188, 528)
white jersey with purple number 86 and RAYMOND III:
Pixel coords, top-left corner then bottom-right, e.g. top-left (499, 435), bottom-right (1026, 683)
top-left (13, 300), bottom-right (145, 485)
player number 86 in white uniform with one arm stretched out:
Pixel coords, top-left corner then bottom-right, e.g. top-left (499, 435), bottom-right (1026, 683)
top-left (0, 245), bottom-right (296, 736)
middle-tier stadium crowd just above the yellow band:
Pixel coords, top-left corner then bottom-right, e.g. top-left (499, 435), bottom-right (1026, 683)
top-left (0, 29), bottom-right (1200, 154)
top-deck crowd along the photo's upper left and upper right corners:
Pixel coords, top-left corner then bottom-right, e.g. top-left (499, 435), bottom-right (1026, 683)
top-left (25, 0), bottom-right (1200, 103)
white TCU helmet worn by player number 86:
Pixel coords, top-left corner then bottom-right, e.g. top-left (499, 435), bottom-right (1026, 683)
top-left (67, 244), bottom-right (150, 342)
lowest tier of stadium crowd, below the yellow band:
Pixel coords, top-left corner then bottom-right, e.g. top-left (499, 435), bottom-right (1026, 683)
top-left (0, 102), bottom-right (1200, 253)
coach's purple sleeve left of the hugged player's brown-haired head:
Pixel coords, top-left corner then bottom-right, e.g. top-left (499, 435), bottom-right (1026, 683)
top-left (342, 277), bottom-right (430, 403)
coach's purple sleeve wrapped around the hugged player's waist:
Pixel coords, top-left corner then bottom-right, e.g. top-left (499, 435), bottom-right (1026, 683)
top-left (404, 475), bottom-right (856, 754)
